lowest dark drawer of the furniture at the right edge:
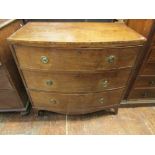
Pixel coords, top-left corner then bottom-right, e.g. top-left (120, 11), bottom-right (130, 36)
top-left (129, 89), bottom-right (155, 99)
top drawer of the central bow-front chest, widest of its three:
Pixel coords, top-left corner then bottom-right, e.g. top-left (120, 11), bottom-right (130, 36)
top-left (15, 45), bottom-right (141, 71)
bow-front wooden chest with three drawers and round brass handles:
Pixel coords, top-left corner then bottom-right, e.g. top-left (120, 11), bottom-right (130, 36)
top-left (8, 22), bottom-right (145, 114)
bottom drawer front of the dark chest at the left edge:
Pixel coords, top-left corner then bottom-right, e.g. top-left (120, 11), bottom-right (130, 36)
top-left (0, 90), bottom-right (21, 109)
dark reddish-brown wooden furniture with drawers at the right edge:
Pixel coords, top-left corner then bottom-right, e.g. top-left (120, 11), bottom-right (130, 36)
top-left (122, 19), bottom-right (155, 106)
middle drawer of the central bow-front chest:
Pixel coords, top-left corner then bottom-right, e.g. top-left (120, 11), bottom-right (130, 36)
top-left (23, 69), bottom-right (130, 92)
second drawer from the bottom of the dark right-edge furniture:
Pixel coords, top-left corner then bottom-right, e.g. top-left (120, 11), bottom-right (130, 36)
top-left (134, 76), bottom-right (155, 88)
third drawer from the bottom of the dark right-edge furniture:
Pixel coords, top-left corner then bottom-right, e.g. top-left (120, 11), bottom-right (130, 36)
top-left (140, 63), bottom-right (155, 75)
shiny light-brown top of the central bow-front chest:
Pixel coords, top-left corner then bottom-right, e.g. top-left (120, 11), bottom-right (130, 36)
top-left (8, 22), bottom-right (146, 46)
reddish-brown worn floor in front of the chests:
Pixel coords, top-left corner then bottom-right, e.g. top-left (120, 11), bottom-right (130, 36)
top-left (0, 107), bottom-right (155, 135)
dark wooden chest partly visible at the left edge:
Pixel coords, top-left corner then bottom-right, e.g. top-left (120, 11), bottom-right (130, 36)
top-left (0, 20), bottom-right (29, 114)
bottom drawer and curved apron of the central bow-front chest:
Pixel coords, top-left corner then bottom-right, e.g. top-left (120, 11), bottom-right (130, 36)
top-left (30, 89), bottom-right (123, 114)
